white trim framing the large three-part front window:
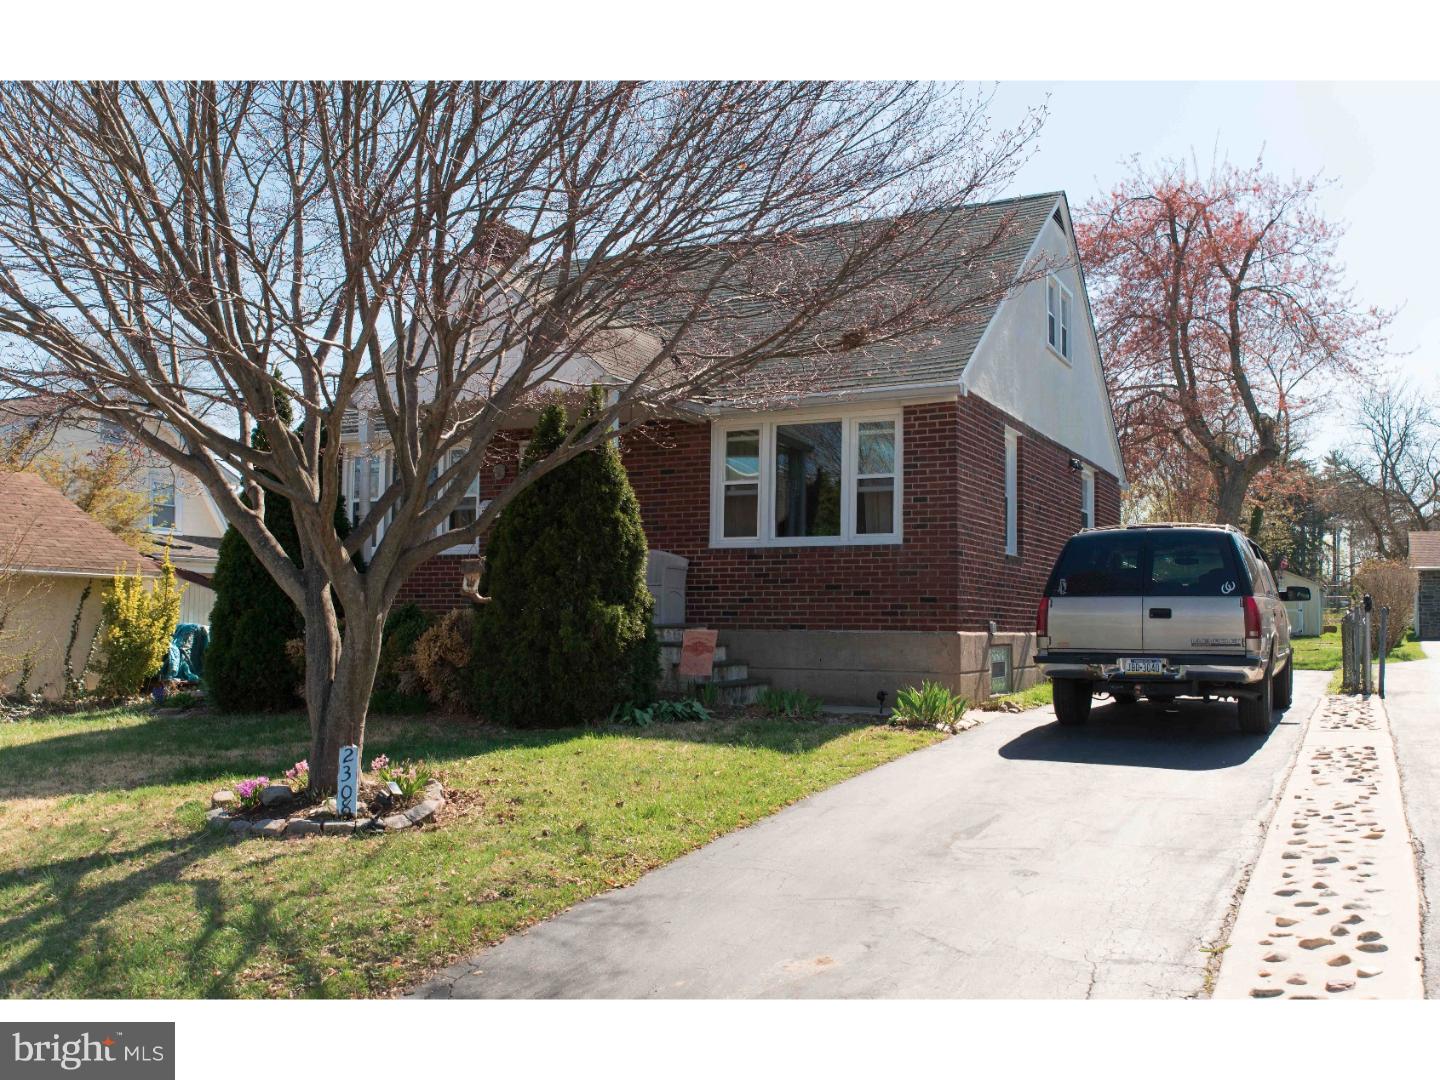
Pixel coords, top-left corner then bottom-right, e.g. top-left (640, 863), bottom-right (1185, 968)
top-left (710, 408), bottom-right (904, 547)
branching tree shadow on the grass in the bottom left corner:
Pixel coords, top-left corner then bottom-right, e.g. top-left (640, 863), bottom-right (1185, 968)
top-left (0, 834), bottom-right (336, 998)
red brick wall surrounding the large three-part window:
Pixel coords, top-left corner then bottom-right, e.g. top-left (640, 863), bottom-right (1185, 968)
top-left (399, 395), bottom-right (1120, 631)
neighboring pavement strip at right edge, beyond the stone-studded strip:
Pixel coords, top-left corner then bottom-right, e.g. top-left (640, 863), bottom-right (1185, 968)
top-left (1385, 641), bottom-right (1440, 998)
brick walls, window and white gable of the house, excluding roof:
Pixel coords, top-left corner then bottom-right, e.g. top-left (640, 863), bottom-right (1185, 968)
top-left (347, 193), bottom-right (1123, 704)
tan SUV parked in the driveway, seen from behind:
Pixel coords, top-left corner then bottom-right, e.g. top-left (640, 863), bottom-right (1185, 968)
top-left (1035, 524), bottom-right (1310, 734)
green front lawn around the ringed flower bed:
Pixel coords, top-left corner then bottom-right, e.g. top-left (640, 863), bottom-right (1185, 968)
top-left (0, 710), bottom-right (942, 998)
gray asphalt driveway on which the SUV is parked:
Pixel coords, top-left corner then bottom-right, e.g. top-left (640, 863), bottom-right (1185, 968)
top-left (416, 671), bottom-right (1326, 998)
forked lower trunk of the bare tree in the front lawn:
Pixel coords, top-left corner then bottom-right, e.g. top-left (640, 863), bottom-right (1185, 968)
top-left (305, 582), bottom-right (383, 795)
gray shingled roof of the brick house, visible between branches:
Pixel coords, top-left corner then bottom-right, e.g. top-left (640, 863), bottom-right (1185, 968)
top-left (593, 193), bottom-right (1060, 396)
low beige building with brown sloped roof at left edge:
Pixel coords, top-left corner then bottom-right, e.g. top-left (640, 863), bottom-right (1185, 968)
top-left (0, 472), bottom-right (160, 698)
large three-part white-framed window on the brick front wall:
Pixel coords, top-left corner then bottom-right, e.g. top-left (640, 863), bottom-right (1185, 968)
top-left (710, 410), bottom-right (901, 547)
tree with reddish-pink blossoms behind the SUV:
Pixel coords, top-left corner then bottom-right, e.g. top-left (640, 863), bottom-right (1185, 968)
top-left (1076, 163), bottom-right (1390, 526)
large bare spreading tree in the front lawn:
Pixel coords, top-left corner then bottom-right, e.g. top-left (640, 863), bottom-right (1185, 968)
top-left (0, 82), bottom-right (1040, 791)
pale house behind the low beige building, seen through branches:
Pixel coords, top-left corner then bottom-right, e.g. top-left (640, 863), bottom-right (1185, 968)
top-left (0, 396), bottom-right (225, 625)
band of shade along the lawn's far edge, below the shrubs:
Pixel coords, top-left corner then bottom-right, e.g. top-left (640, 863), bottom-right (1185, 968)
top-left (0, 713), bottom-right (865, 799)
